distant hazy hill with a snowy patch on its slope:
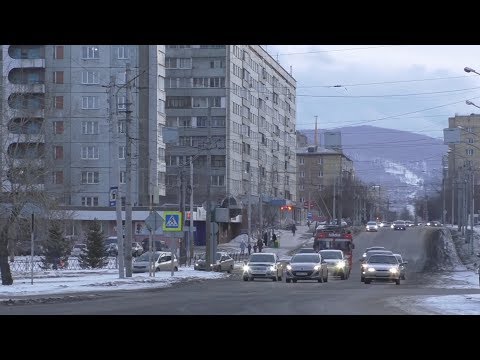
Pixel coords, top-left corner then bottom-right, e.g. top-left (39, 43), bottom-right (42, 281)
top-left (299, 126), bottom-right (448, 210)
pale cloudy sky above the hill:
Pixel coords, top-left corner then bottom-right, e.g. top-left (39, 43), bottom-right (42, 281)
top-left (264, 45), bottom-right (480, 138)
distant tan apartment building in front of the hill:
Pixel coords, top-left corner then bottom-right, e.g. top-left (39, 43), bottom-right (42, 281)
top-left (297, 145), bottom-right (354, 219)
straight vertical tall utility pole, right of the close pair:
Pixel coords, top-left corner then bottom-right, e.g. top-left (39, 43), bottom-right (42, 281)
top-left (125, 63), bottom-right (132, 277)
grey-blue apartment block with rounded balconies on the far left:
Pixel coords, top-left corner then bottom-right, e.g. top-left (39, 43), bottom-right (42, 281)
top-left (0, 45), bottom-right (166, 242)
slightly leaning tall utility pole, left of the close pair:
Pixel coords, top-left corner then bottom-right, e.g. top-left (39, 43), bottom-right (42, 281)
top-left (108, 75), bottom-right (125, 279)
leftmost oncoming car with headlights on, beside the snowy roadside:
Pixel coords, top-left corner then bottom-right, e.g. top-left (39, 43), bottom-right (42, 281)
top-left (242, 253), bottom-right (283, 281)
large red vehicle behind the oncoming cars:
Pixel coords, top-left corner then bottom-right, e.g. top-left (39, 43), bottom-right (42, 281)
top-left (313, 226), bottom-right (355, 271)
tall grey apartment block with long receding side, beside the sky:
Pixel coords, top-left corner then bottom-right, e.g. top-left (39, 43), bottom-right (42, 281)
top-left (165, 45), bottom-right (296, 215)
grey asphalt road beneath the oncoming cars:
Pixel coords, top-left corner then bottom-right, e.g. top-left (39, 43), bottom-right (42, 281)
top-left (0, 227), bottom-right (480, 315)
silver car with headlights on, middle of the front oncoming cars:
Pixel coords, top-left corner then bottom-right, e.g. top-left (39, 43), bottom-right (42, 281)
top-left (285, 253), bottom-right (328, 283)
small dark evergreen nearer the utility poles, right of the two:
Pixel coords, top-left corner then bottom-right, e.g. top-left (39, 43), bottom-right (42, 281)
top-left (78, 218), bottom-right (108, 269)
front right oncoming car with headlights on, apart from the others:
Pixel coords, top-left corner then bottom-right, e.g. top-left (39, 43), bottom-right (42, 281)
top-left (364, 254), bottom-right (400, 285)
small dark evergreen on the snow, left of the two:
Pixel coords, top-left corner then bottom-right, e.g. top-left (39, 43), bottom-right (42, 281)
top-left (41, 221), bottom-right (72, 269)
